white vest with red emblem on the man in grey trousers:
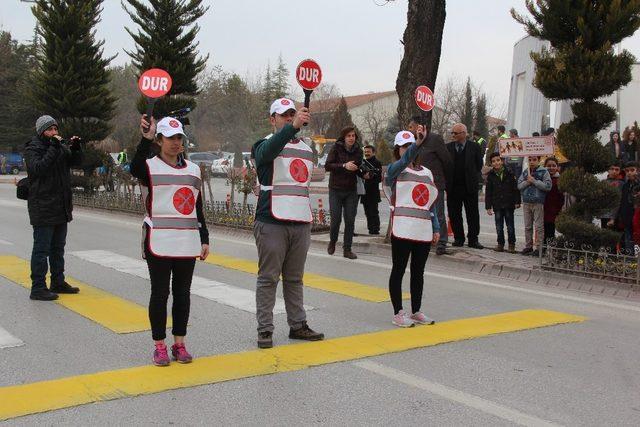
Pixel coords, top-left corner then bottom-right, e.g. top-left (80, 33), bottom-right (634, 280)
top-left (260, 139), bottom-right (313, 223)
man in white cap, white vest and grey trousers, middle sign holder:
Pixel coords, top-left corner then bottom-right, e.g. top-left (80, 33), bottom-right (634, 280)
top-left (251, 98), bottom-right (324, 348)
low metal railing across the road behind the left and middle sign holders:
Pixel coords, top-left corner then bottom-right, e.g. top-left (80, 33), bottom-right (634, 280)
top-left (73, 191), bottom-right (331, 233)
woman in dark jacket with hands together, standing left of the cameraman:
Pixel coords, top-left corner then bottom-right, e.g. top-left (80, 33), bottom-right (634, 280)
top-left (324, 126), bottom-right (363, 259)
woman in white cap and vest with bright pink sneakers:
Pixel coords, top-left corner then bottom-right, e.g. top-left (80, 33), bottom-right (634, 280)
top-left (131, 115), bottom-right (209, 366)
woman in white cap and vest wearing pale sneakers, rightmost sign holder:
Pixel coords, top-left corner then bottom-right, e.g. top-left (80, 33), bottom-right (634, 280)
top-left (385, 126), bottom-right (440, 327)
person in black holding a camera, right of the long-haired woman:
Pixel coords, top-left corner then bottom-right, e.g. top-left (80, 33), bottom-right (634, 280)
top-left (360, 145), bottom-right (382, 234)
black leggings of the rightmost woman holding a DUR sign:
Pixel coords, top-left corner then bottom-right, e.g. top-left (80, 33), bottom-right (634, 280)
top-left (389, 236), bottom-right (431, 314)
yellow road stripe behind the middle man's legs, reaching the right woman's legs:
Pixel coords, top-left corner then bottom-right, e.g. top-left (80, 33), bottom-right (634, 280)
top-left (205, 254), bottom-right (411, 302)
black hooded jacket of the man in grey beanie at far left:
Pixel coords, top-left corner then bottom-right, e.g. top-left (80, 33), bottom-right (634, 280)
top-left (24, 136), bottom-right (82, 226)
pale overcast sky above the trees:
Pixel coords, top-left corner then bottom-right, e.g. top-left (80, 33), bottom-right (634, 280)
top-left (0, 0), bottom-right (640, 113)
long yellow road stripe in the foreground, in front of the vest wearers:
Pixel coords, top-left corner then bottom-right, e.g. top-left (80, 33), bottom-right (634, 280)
top-left (0, 310), bottom-right (586, 420)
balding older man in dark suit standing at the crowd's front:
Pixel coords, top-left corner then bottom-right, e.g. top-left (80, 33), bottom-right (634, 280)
top-left (447, 123), bottom-right (484, 249)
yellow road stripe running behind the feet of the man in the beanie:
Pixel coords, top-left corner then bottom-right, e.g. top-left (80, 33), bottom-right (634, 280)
top-left (0, 255), bottom-right (154, 334)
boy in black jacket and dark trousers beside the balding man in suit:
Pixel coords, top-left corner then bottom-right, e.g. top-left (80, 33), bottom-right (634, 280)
top-left (484, 153), bottom-right (520, 253)
